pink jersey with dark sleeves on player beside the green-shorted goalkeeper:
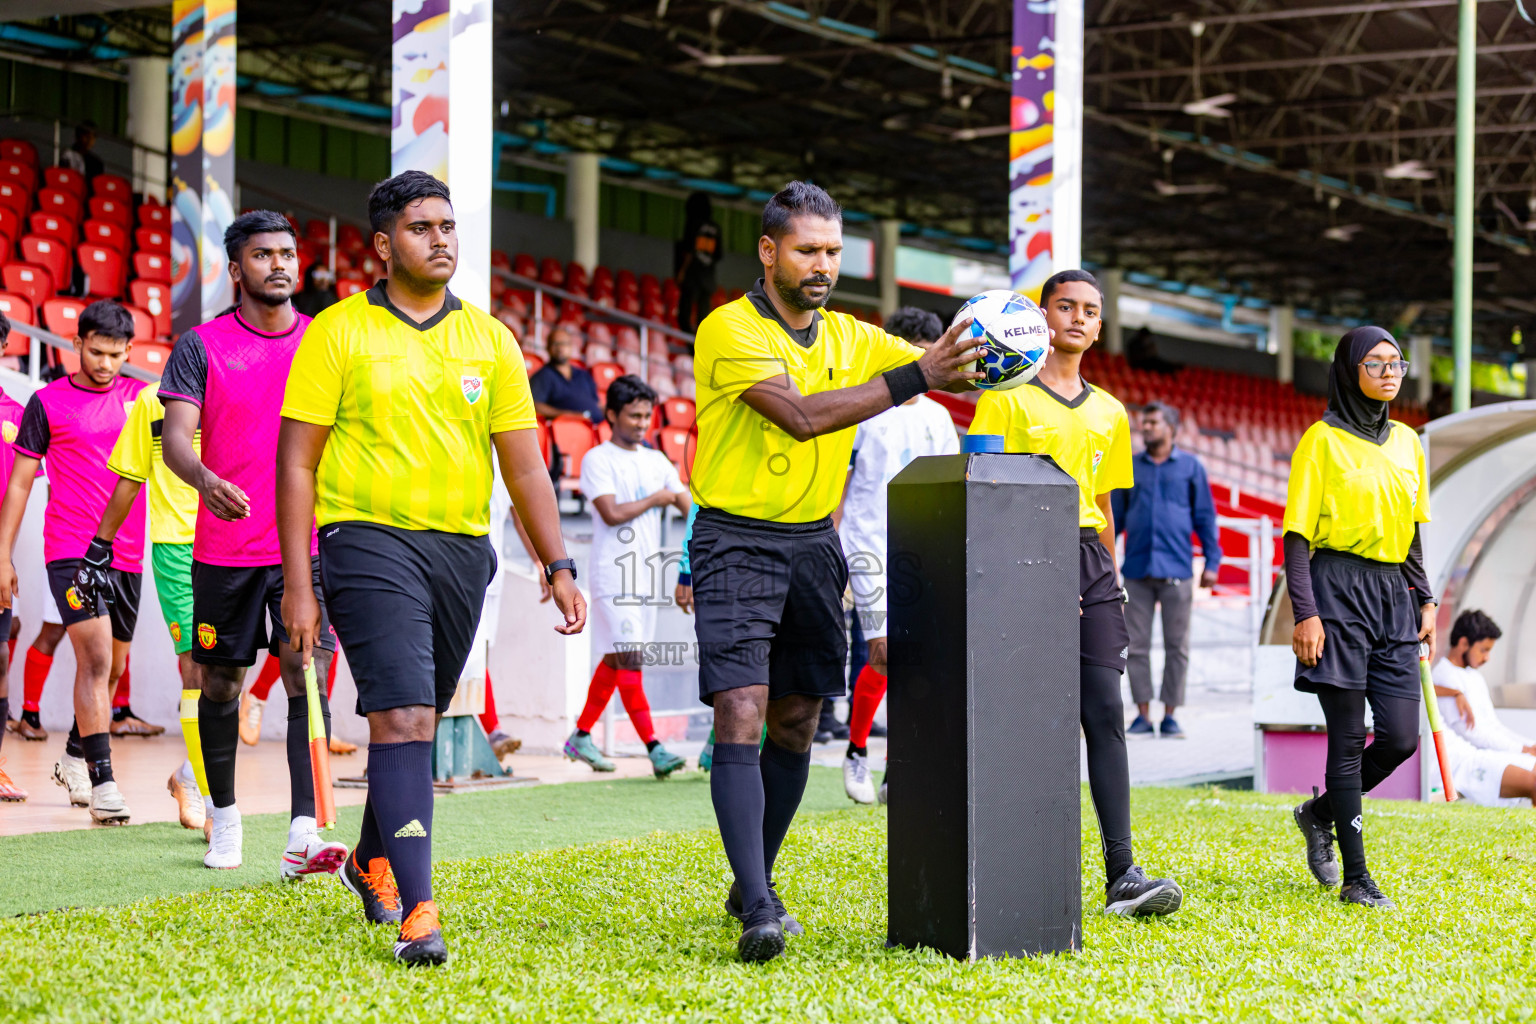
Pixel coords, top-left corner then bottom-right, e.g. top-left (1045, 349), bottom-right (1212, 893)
top-left (15, 376), bottom-right (144, 573)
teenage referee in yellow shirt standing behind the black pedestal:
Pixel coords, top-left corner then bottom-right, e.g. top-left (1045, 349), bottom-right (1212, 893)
top-left (971, 270), bottom-right (1184, 917)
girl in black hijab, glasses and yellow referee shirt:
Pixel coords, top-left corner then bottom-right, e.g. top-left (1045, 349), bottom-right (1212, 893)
top-left (1284, 327), bottom-right (1436, 909)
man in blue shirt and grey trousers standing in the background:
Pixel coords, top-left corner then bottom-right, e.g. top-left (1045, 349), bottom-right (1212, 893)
top-left (1112, 402), bottom-right (1221, 738)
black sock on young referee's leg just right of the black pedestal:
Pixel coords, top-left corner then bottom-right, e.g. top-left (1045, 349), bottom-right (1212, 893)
top-left (1080, 665), bottom-right (1135, 884)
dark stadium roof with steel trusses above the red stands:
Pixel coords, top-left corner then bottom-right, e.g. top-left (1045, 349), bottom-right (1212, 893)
top-left (12, 0), bottom-right (1536, 358)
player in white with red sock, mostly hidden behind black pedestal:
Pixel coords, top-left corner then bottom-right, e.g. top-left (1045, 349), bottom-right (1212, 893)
top-left (837, 306), bottom-right (960, 803)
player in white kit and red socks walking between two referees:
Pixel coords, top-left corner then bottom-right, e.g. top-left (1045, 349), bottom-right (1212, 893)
top-left (565, 375), bottom-right (690, 778)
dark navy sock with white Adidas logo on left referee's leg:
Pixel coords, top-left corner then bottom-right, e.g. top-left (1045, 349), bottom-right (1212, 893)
top-left (369, 740), bottom-right (432, 917)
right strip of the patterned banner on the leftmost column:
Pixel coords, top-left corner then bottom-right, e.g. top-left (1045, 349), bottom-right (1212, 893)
top-left (200, 0), bottom-right (235, 318)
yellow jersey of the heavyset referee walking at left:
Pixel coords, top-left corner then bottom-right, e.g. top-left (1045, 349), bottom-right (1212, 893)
top-left (283, 281), bottom-right (538, 536)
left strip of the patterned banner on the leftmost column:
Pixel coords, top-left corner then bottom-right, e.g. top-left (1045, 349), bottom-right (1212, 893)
top-left (169, 0), bottom-right (203, 335)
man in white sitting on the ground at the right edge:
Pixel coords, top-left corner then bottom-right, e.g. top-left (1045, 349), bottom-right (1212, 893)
top-left (1433, 609), bottom-right (1536, 808)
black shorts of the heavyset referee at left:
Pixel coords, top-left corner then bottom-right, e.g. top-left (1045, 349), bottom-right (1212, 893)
top-left (319, 522), bottom-right (496, 715)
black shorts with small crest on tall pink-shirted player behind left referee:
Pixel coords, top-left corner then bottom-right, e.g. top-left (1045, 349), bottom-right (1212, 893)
top-left (192, 559), bottom-right (336, 668)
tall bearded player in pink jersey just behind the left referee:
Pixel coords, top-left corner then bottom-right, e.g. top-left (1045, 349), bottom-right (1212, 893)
top-left (160, 210), bottom-right (347, 878)
